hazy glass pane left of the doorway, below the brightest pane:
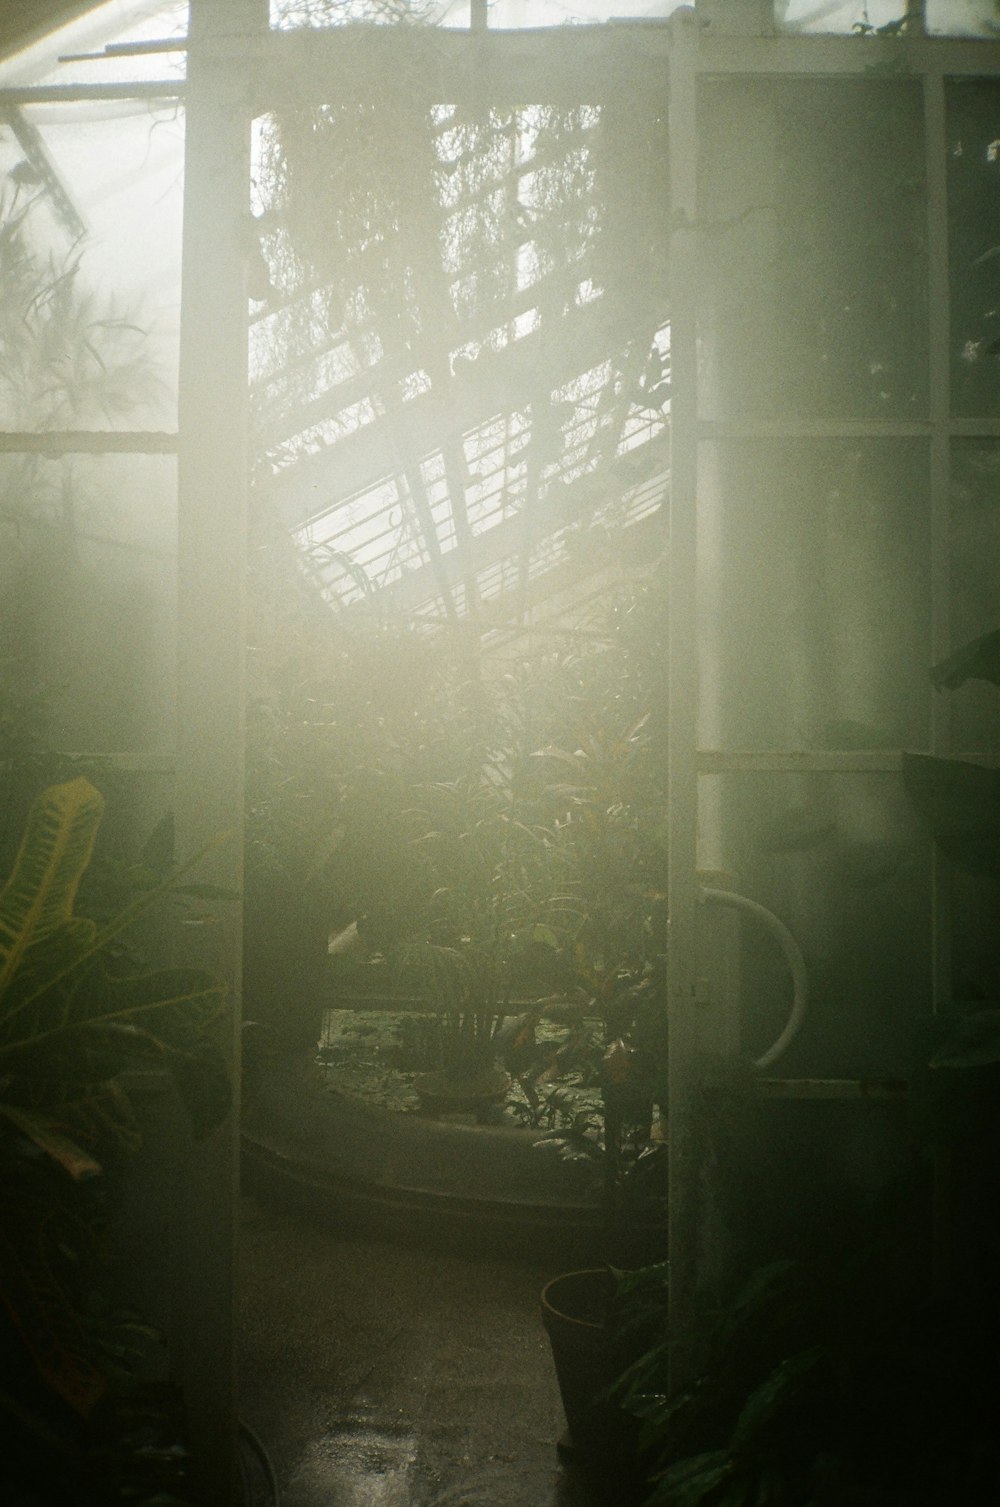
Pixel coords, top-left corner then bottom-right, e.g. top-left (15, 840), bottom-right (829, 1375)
top-left (0, 454), bottom-right (176, 754)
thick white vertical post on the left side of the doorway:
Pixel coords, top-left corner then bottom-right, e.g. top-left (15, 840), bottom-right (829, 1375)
top-left (170, 0), bottom-right (268, 1507)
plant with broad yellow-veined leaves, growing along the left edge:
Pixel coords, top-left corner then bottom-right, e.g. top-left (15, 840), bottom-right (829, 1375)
top-left (0, 778), bottom-right (229, 1502)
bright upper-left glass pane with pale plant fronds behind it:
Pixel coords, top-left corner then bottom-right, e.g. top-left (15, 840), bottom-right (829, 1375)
top-left (0, 101), bottom-right (184, 429)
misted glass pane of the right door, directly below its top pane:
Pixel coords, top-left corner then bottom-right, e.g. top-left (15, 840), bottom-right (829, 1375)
top-left (699, 440), bottom-right (929, 749)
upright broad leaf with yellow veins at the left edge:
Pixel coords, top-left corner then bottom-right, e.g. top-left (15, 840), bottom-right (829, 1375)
top-left (0, 778), bottom-right (104, 1013)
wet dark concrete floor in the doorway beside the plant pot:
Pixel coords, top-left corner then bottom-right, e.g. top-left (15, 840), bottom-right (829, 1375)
top-left (241, 1200), bottom-right (595, 1507)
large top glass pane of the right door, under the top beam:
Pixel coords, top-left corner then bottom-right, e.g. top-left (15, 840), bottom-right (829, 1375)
top-left (699, 78), bottom-right (926, 419)
